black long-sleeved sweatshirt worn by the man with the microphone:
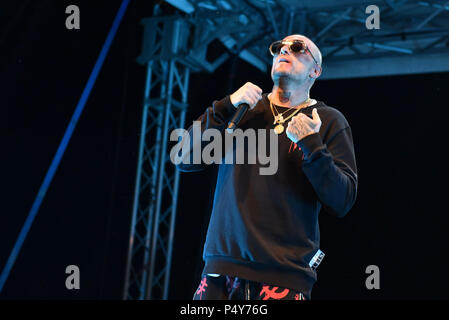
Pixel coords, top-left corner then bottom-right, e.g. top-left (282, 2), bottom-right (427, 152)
top-left (178, 94), bottom-right (357, 299)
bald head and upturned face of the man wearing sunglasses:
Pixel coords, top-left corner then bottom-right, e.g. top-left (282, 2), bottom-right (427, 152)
top-left (271, 35), bottom-right (320, 83)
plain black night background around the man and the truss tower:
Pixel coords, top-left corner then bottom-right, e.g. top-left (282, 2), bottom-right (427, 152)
top-left (0, 0), bottom-right (449, 300)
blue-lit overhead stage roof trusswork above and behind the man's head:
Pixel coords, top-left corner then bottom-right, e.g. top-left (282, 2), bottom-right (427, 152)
top-left (163, 0), bottom-right (449, 79)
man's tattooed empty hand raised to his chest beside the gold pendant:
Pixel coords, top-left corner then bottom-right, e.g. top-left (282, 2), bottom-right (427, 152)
top-left (286, 108), bottom-right (321, 143)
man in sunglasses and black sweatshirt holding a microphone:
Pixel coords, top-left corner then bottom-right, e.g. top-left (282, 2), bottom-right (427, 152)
top-left (179, 35), bottom-right (357, 300)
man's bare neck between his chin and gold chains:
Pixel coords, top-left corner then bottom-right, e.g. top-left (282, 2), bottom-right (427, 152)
top-left (270, 77), bottom-right (309, 108)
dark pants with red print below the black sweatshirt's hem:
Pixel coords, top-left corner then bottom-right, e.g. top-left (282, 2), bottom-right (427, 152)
top-left (193, 275), bottom-right (305, 300)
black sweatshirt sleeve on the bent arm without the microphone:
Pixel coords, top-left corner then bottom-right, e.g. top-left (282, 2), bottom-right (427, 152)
top-left (297, 120), bottom-right (357, 217)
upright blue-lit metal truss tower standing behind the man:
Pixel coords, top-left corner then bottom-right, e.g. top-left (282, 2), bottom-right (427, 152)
top-left (123, 19), bottom-right (190, 300)
